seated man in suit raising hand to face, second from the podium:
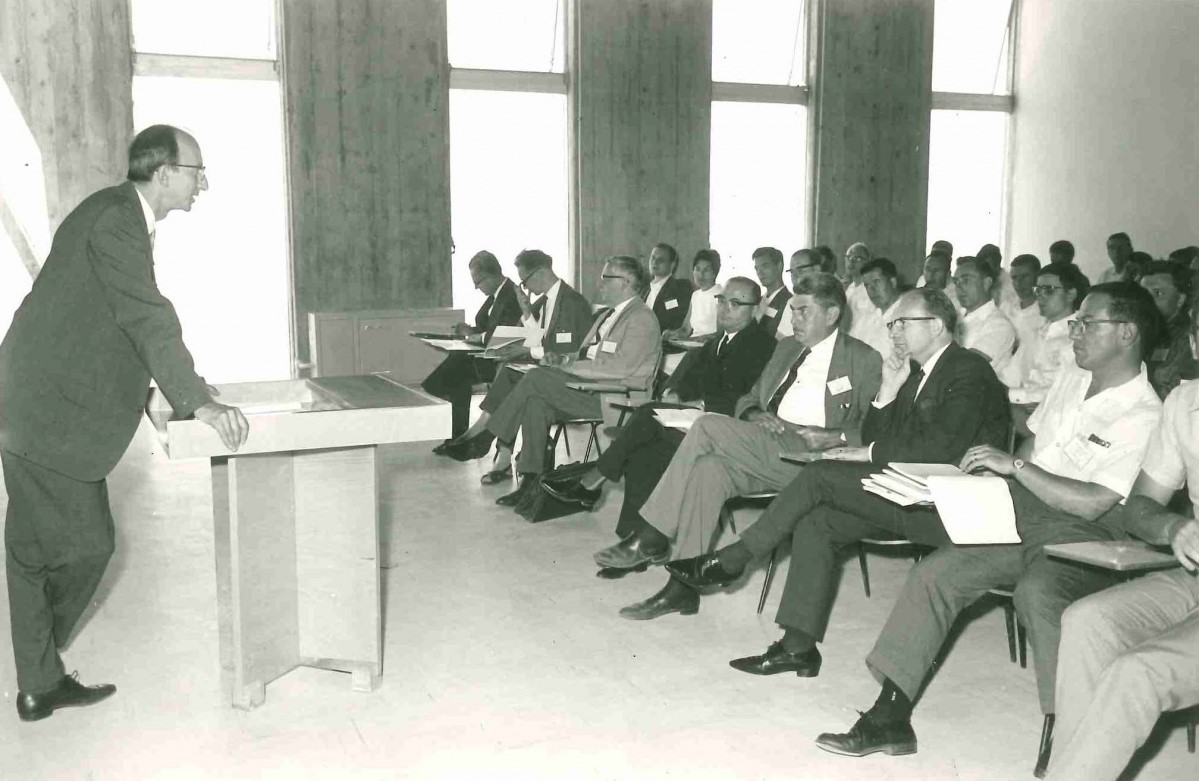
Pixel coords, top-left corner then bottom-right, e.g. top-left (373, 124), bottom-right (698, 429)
top-left (435, 250), bottom-right (595, 472)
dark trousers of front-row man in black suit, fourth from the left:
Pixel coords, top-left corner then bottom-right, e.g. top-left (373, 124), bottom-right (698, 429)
top-left (596, 403), bottom-right (686, 539)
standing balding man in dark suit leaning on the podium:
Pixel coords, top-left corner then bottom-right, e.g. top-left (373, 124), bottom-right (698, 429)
top-left (0, 125), bottom-right (249, 721)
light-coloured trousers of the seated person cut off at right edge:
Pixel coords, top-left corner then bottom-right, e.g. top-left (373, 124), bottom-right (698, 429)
top-left (1049, 570), bottom-right (1199, 781)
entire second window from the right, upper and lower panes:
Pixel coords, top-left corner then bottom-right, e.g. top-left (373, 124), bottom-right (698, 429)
top-left (709, 0), bottom-right (808, 280)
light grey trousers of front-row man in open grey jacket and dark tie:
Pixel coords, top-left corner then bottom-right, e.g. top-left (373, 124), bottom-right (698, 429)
top-left (641, 415), bottom-right (807, 559)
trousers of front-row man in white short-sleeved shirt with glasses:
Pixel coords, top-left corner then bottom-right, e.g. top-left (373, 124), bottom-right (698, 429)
top-left (866, 494), bottom-right (1115, 714)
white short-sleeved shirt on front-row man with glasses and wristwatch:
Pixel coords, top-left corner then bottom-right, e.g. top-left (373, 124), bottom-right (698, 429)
top-left (1029, 366), bottom-right (1162, 501)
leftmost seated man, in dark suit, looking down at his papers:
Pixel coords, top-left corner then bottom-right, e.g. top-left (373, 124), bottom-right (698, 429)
top-left (421, 250), bottom-right (520, 443)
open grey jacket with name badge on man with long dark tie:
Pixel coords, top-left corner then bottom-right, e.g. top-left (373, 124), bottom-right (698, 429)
top-left (734, 331), bottom-right (882, 445)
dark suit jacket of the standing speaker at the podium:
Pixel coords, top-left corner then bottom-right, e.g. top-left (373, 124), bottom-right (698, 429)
top-left (0, 182), bottom-right (210, 481)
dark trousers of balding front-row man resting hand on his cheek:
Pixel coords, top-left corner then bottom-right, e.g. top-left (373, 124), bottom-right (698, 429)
top-left (741, 461), bottom-right (948, 641)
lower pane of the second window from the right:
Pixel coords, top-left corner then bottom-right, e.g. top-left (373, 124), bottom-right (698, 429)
top-left (710, 101), bottom-right (808, 281)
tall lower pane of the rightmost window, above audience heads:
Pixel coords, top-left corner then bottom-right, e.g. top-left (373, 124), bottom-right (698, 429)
top-left (928, 110), bottom-right (1008, 256)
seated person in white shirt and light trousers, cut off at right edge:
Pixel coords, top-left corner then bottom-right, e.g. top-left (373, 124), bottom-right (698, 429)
top-left (1048, 333), bottom-right (1199, 781)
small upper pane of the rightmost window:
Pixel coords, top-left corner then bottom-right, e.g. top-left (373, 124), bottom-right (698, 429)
top-left (933, 0), bottom-right (1013, 95)
